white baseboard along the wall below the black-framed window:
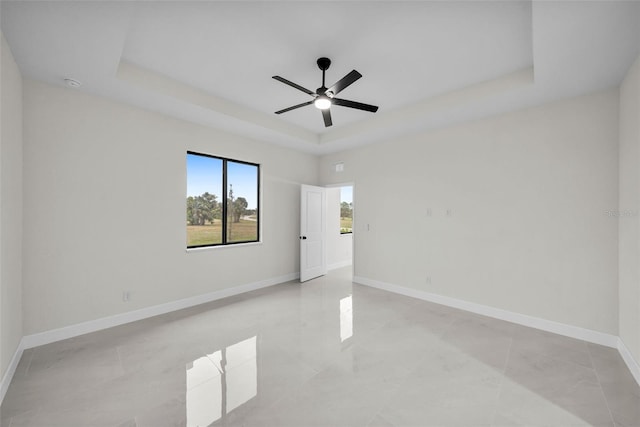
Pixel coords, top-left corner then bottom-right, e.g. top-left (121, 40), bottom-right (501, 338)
top-left (23, 273), bottom-right (300, 349)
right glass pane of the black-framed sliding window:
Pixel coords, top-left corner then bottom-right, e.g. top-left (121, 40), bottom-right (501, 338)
top-left (227, 160), bottom-right (259, 242)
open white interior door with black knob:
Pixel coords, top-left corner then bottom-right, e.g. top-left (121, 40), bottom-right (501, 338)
top-left (300, 185), bottom-right (327, 282)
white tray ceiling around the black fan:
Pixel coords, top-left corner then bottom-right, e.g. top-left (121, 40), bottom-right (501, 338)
top-left (0, 0), bottom-right (640, 154)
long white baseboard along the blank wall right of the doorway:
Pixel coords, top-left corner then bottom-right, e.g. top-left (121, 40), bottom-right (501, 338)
top-left (353, 276), bottom-right (619, 348)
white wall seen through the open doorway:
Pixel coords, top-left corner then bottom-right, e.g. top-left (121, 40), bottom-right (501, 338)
top-left (327, 187), bottom-right (353, 270)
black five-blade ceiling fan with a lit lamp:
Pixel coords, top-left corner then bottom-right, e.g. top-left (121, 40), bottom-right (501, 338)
top-left (273, 58), bottom-right (378, 127)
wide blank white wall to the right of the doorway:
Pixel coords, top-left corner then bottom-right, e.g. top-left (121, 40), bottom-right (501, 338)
top-left (320, 90), bottom-right (618, 335)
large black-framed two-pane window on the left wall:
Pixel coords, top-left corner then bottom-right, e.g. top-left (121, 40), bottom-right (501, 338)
top-left (187, 151), bottom-right (260, 248)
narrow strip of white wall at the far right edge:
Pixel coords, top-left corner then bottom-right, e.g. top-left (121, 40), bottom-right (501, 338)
top-left (618, 52), bottom-right (640, 361)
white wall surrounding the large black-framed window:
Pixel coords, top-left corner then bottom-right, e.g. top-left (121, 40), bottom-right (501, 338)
top-left (24, 80), bottom-right (318, 335)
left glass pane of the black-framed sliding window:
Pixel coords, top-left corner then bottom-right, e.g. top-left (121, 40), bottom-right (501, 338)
top-left (187, 153), bottom-right (223, 247)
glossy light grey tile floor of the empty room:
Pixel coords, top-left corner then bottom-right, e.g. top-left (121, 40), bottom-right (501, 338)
top-left (0, 268), bottom-right (640, 427)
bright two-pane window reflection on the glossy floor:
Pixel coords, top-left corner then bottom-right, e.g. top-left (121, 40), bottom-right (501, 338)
top-left (187, 336), bottom-right (258, 427)
